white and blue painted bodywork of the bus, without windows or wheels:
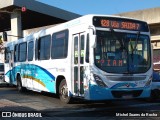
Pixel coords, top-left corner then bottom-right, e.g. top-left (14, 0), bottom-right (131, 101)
top-left (5, 15), bottom-right (152, 100)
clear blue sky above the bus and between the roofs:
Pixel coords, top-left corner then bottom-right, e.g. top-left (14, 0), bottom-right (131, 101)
top-left (36, 0), bottom-right (160, 15)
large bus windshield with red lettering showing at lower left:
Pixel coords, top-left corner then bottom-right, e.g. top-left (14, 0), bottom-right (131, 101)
top-left (94, 30), bottom-right (151, 74)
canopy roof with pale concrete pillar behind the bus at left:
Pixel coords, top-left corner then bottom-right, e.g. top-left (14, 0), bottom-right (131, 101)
top-left (0, 0), bottom-right (80, 41)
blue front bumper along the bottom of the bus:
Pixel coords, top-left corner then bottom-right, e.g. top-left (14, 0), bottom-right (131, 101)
top-left (86, 85), bottom-right (151, 100)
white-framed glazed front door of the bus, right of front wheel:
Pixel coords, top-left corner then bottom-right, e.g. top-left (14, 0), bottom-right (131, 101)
top-left (72, 33), bottom-right (86, 96)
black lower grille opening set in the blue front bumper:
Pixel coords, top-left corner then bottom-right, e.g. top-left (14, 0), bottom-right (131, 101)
top-left (112, 90), bottom-right (143, 98)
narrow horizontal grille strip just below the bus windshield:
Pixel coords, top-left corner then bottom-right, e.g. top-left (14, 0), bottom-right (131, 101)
top-left (107, 76), bottom-right (146, 81)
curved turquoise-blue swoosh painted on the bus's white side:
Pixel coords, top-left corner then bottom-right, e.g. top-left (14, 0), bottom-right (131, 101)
top-left (6, 64), bottom-right (55, 92)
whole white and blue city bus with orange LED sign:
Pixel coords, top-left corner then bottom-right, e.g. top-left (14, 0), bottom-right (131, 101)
top-left (5, 15), bottom-right (153, 103)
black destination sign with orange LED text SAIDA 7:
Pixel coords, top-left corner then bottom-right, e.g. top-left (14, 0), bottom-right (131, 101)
top-left (93, 17), bottom-right (149, 32)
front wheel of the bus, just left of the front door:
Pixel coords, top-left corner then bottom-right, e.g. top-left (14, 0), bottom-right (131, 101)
top-left (59, 79), bottom-right (71, 104)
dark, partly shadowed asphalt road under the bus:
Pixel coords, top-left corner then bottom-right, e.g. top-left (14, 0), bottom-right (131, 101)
top-left (0, 86), bottom-right (160, 120)
